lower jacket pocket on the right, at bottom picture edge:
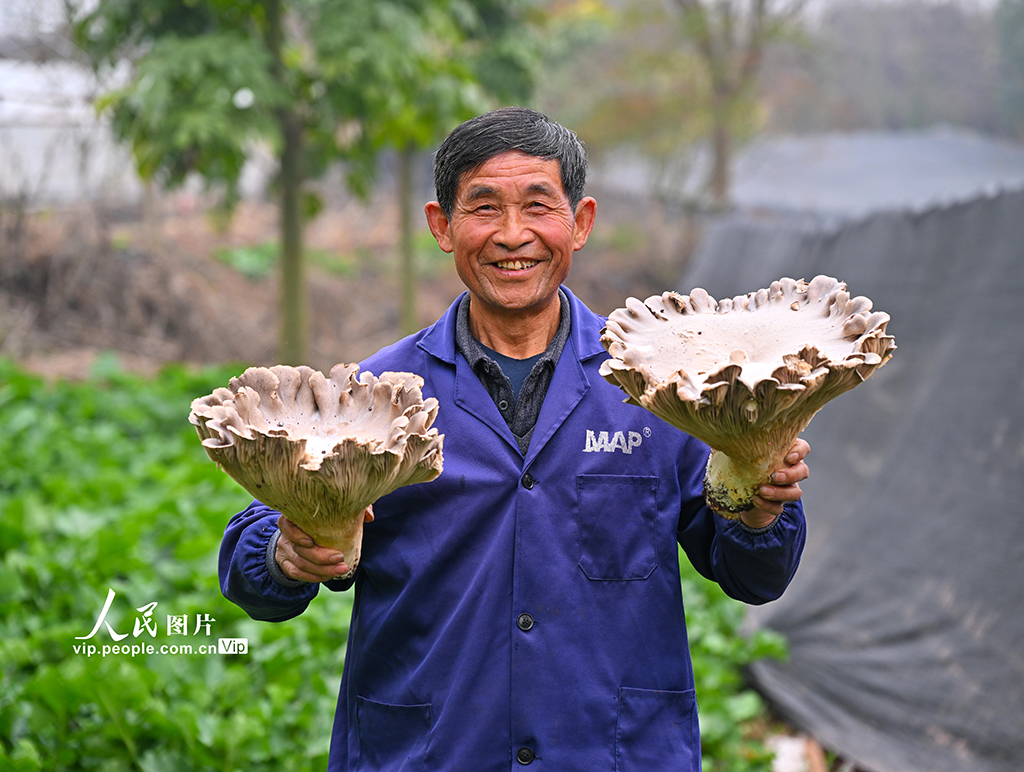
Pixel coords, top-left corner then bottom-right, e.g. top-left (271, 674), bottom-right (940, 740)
top-left (615, 686), bottom-right (700, 772)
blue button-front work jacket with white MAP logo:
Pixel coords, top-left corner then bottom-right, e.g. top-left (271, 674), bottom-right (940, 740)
top-left (220, 291), bottom-right (804, 772)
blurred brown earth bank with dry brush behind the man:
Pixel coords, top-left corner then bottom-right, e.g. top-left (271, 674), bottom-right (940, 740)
top-left (0, 190), bottom-right (692, 378)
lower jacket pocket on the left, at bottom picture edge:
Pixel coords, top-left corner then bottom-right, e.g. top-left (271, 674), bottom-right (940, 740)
top-left (356, 697), bottom-right (430, 772)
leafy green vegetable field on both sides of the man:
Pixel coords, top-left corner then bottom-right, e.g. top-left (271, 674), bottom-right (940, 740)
top-left (0, 358), bottom-right (783, 772)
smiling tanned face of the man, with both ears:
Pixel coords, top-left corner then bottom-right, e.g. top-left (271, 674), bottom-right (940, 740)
top-left (427, 152), bottom-right (596, 313)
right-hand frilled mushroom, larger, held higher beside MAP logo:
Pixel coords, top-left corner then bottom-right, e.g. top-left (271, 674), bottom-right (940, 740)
top-left (601, 276), bottom-right (896, 519)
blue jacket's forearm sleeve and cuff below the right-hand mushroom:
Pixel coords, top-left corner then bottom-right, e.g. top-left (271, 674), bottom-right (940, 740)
top-left (678, 442), bottom-right (807, 605)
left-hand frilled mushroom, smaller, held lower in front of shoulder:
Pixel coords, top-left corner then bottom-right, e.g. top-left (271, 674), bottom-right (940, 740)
top-left (188, 364), bottom-right (444, 571)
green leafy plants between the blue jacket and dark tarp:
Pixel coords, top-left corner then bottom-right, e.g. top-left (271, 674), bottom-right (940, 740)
top-left (680, 552), bottom-right (786, 772)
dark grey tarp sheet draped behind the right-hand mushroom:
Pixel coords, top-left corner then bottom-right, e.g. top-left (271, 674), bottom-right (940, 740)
top-left (680, 191), bottom-right (1024, 772)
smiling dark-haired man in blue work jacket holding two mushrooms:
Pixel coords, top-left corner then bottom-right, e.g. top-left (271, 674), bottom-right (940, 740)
top-left (220, 108), bottom-right (808, 772)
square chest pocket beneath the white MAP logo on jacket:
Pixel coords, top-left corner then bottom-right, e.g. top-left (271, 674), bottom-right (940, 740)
top-left (577, 474), bottom-right (657, 581)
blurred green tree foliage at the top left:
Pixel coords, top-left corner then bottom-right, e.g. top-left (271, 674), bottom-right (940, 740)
top-left (69, 0), bottom-right (536, 201)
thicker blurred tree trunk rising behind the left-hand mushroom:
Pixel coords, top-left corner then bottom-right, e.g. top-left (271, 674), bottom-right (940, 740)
top-left (278, 112), bottom-right (306, 367)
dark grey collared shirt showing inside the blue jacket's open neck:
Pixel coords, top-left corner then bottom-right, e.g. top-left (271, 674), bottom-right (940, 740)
top-left (455, 290), bottom-right (571, 456)
